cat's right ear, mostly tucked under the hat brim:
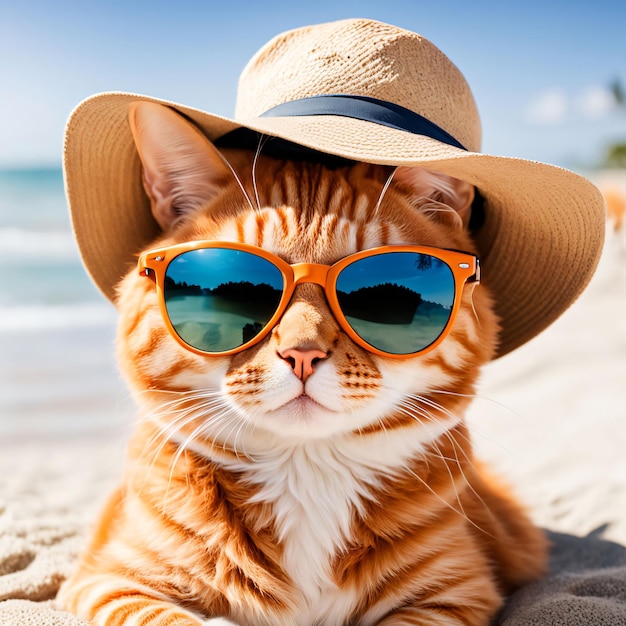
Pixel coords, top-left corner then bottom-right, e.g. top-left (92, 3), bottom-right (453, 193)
top-left (393, 167), bottom-right (475, 228)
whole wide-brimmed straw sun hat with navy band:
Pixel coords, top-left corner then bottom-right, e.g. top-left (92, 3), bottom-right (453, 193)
top-left (64, 19), bottom-right (604, 356)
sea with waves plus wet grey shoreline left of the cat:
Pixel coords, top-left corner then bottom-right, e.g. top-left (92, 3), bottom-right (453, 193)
top-left (0, 167), bottom-right (129, 439)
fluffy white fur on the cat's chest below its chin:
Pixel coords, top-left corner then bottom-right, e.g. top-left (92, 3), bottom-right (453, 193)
top-left (222, 420), bottom-right (456, 624)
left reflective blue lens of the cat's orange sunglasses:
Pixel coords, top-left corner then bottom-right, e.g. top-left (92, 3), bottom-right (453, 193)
top-left (164, 248), bottom-right (284, 352)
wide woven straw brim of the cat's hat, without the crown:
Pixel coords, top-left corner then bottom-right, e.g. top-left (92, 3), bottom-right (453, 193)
top-left (64, 93), bottom-right (605, 356)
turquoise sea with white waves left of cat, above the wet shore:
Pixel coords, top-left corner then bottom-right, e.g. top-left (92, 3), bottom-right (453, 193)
top-left (0, 168), bottom-right (111, 326)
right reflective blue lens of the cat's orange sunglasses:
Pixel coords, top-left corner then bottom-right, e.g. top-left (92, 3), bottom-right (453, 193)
top-left (337, 252), bottom-right (454, 354)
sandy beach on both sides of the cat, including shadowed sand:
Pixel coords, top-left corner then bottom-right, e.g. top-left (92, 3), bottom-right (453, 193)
top-left (0, 174), bottom-right (626, 626)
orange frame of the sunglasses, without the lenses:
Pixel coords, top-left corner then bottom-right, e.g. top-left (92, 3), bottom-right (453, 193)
top-left (138, 240), bottom-right (480, 359)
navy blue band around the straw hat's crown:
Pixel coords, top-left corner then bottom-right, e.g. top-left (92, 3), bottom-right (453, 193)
top-left (260, 94), bottom-right (467, 150)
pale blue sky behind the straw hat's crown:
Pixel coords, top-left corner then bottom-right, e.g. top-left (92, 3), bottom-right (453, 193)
top-left (0, 0), bottom-right (626, 169)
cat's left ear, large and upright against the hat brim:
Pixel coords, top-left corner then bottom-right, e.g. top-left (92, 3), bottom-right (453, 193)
top-left (128, 102), bottom-right (232, 231)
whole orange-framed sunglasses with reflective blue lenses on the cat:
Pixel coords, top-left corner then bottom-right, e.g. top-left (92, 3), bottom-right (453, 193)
top-left (139, 241), bottom-right (480, 358)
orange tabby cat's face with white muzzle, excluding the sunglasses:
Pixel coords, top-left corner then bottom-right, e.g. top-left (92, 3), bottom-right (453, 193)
top-left (118, 102), bottom-right (496, 447)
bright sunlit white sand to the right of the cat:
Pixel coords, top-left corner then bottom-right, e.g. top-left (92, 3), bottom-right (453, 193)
top-left (470, 212), bottom-right (626, 544)
